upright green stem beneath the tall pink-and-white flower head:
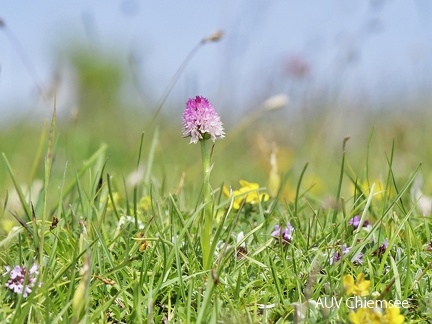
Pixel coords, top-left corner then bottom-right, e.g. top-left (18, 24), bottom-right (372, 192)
top-left (200, 139), bottom-right (212, 270)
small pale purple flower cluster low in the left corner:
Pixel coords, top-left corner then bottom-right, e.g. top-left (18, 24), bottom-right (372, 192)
top-left (3, 263), bottom-right (41, 297)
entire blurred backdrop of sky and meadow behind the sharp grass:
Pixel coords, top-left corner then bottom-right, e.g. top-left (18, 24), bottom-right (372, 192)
top-left (0, 0), bottom-right (432, 199)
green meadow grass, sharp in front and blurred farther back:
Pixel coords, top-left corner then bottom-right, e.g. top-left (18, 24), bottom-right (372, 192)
top-left (0, 105), bottom-right (432, 323)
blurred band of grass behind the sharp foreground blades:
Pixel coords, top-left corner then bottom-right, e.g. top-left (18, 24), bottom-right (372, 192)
top-left (0, 99), bottom-right (432, 196)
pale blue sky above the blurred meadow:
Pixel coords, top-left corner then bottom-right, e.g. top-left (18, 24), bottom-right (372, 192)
top-left (0, 0), bottom-right (432, 119)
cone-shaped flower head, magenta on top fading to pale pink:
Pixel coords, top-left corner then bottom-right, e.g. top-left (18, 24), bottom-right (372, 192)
top-left (183, 96), bottom-right (225, 143)
